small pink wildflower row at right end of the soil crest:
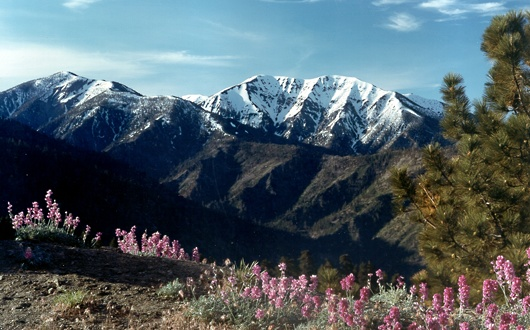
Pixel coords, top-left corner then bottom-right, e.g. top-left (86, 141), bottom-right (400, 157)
top-left (116, 226), bottom-right (200, 262)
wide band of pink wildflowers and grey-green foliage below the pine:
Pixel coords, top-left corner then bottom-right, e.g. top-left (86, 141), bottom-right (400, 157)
top-left (176, 249), bottom-right (530, 330)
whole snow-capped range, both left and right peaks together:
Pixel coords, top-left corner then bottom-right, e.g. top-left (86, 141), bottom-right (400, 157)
top-left (0, 72), bottom-right (442, 174)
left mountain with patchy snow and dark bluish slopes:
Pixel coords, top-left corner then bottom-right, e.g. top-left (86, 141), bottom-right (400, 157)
top-left (0, 72), bottom-right (216, 177)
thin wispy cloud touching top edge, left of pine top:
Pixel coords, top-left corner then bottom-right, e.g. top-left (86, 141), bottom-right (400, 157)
top-left (419, 0), bottom-right (507, 16)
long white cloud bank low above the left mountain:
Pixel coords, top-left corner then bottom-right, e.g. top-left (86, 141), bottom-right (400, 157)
top-left (0, 43), bottom-right (237, 91)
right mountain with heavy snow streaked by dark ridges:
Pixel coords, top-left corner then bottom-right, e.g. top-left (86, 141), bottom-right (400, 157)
top-left (184, 75), bottom-right (442, 153)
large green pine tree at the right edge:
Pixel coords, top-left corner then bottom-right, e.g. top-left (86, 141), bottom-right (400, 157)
top-left (391, 11), bottom-right (530, 292)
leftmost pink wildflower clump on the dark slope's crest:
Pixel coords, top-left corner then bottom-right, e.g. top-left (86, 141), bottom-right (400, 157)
top-left (7, 190), bottom-right (101, 246)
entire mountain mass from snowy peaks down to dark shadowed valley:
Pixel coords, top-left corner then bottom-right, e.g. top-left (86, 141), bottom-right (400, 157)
top-left (0, 72), bottom-right (442, 274)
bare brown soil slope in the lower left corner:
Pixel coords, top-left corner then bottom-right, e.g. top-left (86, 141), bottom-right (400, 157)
top-left (0, 241), bottom-right (217, 330)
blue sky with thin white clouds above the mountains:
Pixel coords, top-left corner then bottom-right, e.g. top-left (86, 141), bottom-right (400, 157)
top-left (0, 0), bottom-right (530, 99)
